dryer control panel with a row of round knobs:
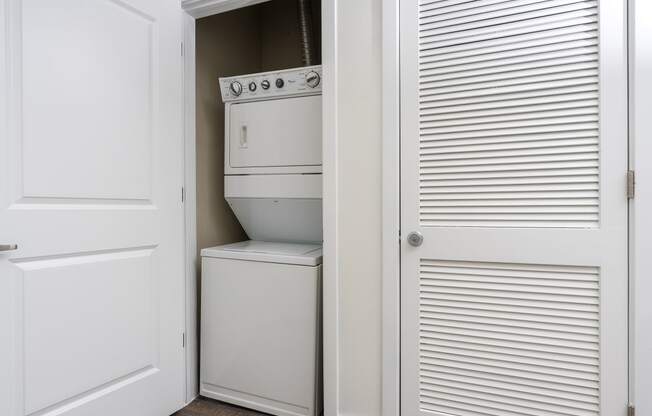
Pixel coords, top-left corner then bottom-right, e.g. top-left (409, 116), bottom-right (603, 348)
top-left (220, 65), bottom-right (322, 103)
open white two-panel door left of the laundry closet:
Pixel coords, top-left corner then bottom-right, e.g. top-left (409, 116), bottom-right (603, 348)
top-left (0, 0), bottom-right (184, 416)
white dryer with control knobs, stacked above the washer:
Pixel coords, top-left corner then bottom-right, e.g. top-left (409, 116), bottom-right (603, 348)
top-left (220, 66), bottom-right (322, 242)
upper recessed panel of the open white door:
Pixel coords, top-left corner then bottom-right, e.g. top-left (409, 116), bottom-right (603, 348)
top-left (19, 0), bottom-right (160, 202)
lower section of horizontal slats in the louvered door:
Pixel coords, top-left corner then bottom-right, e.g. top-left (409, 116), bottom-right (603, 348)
top-left (419, 260), bottom-right (600, 416)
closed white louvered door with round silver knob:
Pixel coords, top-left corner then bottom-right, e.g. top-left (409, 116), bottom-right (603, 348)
top-left (400, 0), bottom-right (627, 416)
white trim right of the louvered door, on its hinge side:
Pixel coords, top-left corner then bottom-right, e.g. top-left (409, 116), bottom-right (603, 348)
top-left (629, 0), bottom-right (652, 415)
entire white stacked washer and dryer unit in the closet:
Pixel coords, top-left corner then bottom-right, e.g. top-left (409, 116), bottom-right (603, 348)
top-left (200, 66), bottom-right (322, 416)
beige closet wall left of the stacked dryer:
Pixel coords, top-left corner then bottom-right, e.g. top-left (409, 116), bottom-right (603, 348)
top-left (195, 8), bottom-right (260, 258)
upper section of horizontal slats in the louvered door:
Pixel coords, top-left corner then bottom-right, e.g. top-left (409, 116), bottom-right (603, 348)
top-left (418, 0), bottom-right (600, 228)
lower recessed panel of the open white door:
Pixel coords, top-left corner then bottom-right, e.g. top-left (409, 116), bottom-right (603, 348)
top-left (18, 247), bottom-right (159, 414)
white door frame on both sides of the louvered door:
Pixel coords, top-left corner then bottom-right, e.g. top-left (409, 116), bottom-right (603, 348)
top-left (381, 0), bottom-right (652, 416)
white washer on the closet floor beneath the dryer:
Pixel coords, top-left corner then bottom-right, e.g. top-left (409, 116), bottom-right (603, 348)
top-left (200, 241), bottom-right (322, 416)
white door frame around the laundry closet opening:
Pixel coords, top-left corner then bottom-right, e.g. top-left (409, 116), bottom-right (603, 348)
top-left (181, 0), bottom-right (339, 416)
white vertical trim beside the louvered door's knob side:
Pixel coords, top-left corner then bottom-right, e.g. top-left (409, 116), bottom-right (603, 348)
top-left (381, 0), bottom-right (401, 416)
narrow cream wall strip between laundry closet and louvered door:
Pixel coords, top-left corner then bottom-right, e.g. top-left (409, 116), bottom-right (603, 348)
top-left (337, 0), bottom-right (382, 415)
